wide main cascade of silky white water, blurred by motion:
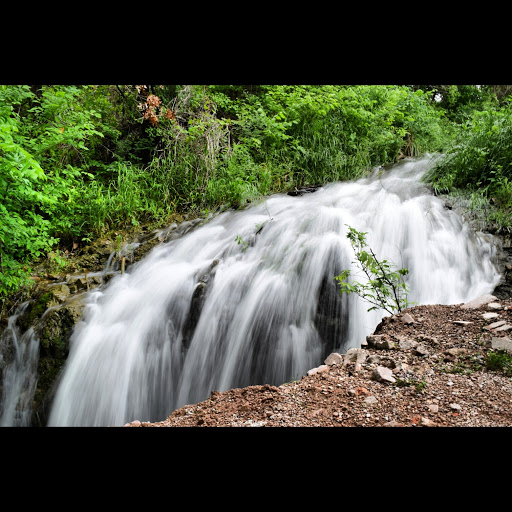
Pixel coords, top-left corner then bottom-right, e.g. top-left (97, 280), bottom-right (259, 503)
top-left (48, 154), bottom-right (500, 426)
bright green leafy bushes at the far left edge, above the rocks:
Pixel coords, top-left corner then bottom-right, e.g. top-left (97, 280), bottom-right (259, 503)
top-left (0, 85), bottom-right (125, 296)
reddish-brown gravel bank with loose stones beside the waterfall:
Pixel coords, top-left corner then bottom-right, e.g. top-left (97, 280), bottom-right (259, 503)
top-left (125, 295), bottom-right (512, 427)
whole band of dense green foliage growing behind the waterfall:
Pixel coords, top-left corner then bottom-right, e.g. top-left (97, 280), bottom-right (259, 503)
top-left (0, 85), bottom-right (512, 296)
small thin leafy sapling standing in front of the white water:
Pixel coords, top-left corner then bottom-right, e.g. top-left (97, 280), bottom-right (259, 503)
top-left (334, 226), bottom-right (412, 315)
